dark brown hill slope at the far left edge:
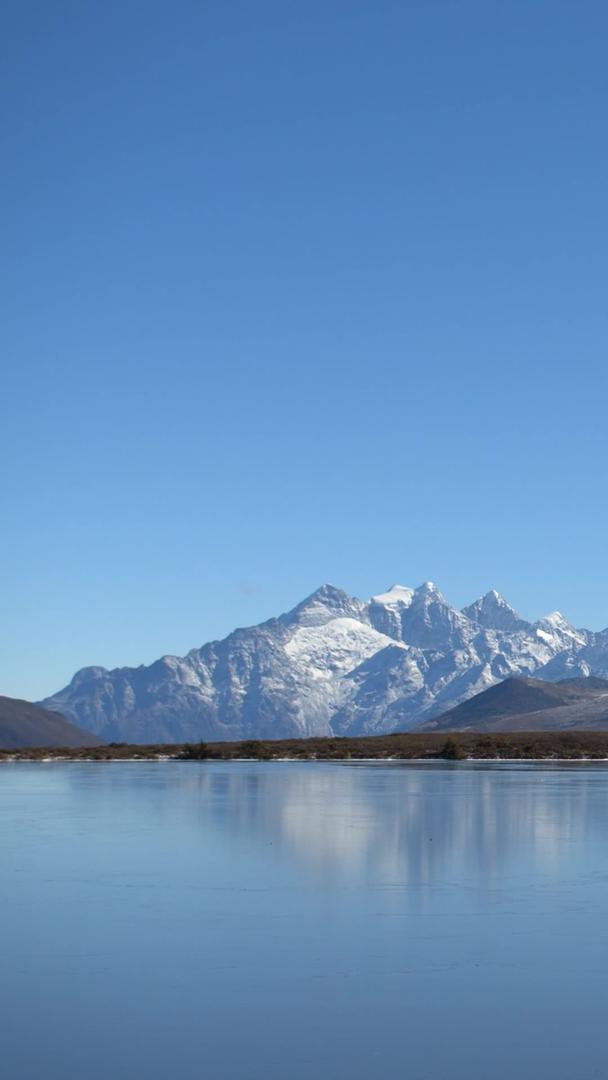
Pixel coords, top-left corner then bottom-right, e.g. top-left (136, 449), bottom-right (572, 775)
top-left (0, 697), bottom-right (103, 750)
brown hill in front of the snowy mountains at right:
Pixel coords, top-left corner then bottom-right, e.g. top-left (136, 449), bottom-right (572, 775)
top-left (419, 676), bottom-right (608, 731)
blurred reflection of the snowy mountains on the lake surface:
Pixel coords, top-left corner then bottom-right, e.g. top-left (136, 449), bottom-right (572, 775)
top-left (159, 762), bottom-right (608, 885)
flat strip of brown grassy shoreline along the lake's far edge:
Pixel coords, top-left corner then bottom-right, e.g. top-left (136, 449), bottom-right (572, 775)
top-left (5, 731), bottom-right (608, 764)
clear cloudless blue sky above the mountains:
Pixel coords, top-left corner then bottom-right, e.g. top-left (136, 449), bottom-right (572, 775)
top-left (0, 0), bottom-right (608, 698)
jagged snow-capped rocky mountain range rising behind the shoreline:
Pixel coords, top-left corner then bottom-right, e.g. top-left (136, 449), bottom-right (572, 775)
top-left (42, 581), bottom-right (608, 742)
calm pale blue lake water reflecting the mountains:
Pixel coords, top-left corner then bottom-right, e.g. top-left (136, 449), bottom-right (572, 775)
top-left (0, 762), bottom-right (608, 1080)
